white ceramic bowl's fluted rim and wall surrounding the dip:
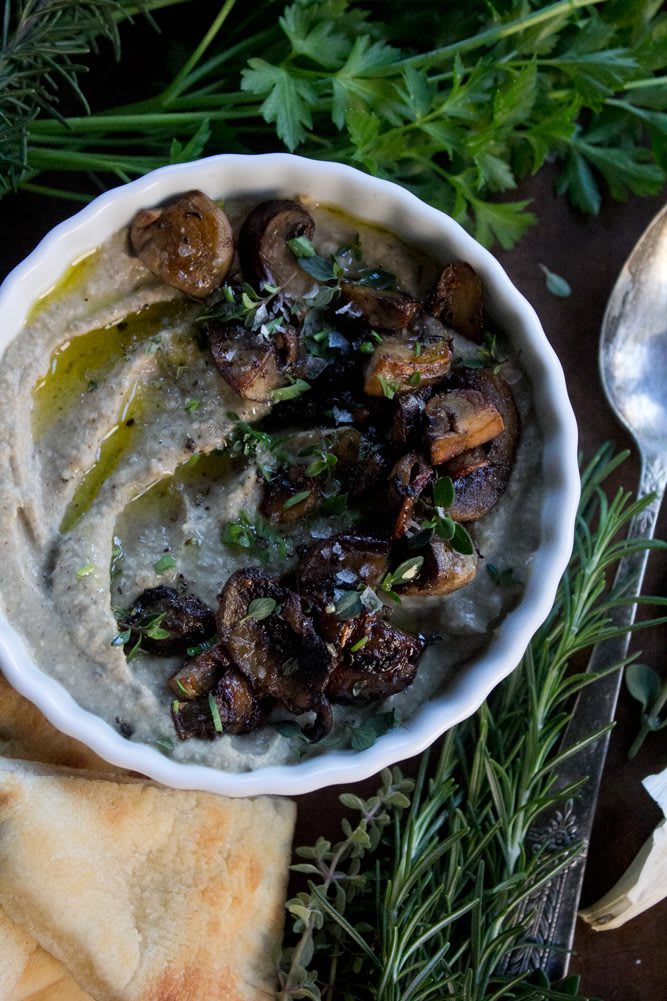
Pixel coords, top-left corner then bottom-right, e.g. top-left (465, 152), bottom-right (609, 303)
top-left (0, 153), bottom-right (579, 796)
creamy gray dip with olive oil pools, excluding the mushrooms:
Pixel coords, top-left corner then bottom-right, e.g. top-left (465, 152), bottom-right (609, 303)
top-left (0, 204), bottom-right (543, 771)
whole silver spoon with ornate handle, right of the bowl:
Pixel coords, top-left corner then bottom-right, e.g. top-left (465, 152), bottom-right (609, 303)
top-left (500, 205), bottom-right (667, 982)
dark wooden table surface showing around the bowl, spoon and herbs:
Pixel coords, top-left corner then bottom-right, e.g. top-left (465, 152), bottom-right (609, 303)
top-left (0, 172), bottom-right (667, 1001)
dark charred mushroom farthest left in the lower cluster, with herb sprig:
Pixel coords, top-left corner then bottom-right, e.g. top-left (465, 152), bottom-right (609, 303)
top-left (127, 585), bottom-right (215, 657)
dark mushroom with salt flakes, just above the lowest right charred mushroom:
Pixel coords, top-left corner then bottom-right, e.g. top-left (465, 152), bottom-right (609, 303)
top-left (295, 532), bottom-right (390, 603)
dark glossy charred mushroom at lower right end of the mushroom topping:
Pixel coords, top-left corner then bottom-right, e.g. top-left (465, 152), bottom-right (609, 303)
top-left (326, 613), bottom-right (426, 703)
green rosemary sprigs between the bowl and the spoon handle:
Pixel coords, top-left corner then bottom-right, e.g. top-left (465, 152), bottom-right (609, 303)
top-left (280, 446), bottom-right (667, 1001)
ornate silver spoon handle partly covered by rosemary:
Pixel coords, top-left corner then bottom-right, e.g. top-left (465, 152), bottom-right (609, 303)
top-left (498, 458), bottom-right (667, 983)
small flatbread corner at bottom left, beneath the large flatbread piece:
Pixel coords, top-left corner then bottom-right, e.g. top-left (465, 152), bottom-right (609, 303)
top-left (0, 911), bottom-right (92, 1001)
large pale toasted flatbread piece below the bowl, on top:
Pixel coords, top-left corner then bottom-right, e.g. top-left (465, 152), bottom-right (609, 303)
top-left (0, 761), bottom-right (295, 1001)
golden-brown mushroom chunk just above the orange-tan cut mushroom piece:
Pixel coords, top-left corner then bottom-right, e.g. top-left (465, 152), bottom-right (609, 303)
top-left (364, 334), bottom-right (452, 396)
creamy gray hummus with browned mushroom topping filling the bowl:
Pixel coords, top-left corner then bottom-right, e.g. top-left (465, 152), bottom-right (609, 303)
top-left (0, 192), bottom-right (543, 771)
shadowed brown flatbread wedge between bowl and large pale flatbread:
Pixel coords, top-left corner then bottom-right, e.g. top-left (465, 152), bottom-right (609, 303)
top-left (0, 674), bottom-right (119, 772)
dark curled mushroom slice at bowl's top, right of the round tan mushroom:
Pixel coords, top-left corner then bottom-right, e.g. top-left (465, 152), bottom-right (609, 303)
top-left (238, 198), bottom-right (314, 297)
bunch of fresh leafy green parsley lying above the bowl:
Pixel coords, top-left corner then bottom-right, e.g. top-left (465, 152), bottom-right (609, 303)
top-left (5, 0), bottom-right (667, 247)
